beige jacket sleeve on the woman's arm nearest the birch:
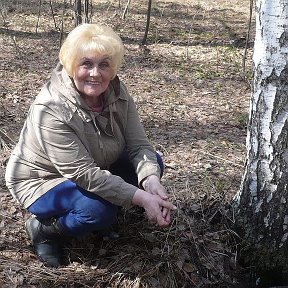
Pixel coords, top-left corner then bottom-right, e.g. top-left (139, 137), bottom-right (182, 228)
top-left (122, 85), bottom-right (160, 184)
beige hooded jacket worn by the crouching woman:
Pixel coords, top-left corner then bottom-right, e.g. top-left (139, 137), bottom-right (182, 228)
top-left (5, 64), bottom-right (160, 208)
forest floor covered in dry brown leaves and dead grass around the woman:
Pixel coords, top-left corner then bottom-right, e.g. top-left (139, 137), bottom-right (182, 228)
top-left (0, 0), bottom-right (254, 288)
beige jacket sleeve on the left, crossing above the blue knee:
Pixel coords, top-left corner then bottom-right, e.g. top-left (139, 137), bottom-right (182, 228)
top-left (29, 104), bottom-right (137, 208)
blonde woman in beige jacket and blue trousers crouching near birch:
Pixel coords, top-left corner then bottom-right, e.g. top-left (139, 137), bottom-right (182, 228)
top-left (5, 24), bottom-right (176, 267)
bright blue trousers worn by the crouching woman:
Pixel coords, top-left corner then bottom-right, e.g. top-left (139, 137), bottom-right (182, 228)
top-left (28, 152), bottom-right (164, 237)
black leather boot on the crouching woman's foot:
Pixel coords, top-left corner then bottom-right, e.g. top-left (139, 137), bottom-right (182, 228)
top-left (25, 217), bottom-right (64, 267)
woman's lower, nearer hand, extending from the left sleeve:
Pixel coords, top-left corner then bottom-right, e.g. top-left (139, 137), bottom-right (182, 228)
top-left (132, 189), bottom-right (177, 227)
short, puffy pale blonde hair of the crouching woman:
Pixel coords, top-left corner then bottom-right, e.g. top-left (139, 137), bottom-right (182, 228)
top-left (59, 23), bottom-right (124, 78)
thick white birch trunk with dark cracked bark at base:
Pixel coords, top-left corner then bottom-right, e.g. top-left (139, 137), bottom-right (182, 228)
top-left (234, 0), bottom-right (288, 284)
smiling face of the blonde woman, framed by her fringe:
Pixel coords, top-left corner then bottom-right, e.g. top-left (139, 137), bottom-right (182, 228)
top-left (73, 56), bottom-right (114, 98)
